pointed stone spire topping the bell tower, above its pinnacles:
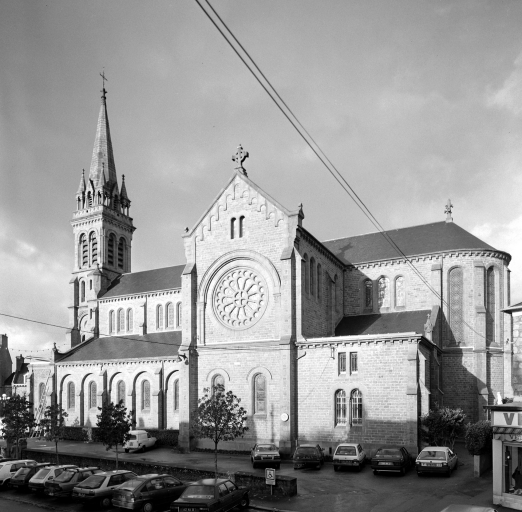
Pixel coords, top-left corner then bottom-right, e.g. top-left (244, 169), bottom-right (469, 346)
top-left (89, 83), bottom-right (118, 189)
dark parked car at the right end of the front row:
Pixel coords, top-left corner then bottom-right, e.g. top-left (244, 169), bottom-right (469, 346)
top-left (170, 478), bottom-right (250, 512)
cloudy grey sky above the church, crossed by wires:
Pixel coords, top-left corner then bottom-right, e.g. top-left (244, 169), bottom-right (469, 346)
top-left (0, 0), bottom-right (522, 356)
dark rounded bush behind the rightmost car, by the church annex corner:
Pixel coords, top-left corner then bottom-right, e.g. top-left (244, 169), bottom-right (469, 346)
top-left (421, 405), bottom-right (466, 450)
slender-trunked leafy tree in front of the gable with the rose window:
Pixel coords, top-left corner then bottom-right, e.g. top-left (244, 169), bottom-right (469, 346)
top-left (192, 384), bottom-right (248, 478)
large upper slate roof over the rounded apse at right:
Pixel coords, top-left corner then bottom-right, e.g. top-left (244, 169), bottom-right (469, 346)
top-left (323, 221), bottom-right (496, 264)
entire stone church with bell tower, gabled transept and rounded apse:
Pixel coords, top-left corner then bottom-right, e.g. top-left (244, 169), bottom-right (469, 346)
top-left (30, 90), bottom-right (513, 454)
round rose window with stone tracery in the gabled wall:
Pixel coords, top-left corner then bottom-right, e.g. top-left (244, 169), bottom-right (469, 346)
top-left (213, 268), bottom-right (268, 329)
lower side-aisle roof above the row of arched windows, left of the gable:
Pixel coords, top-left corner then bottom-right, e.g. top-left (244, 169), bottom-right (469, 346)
top-left (58, 331), bottom-right (181, 363)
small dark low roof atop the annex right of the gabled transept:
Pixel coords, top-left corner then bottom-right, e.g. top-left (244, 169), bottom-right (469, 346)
top-left (335, 309), bottom-right (431, 336)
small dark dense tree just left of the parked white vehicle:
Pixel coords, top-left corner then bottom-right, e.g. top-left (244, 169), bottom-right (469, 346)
top-left (96, 400), bottom-right (132, 469)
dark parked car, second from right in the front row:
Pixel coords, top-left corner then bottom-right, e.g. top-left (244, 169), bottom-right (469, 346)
top-left (112, 474), bottom-right (187, 512)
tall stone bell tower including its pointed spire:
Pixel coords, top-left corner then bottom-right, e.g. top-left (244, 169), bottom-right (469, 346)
top-left (67, 82), bottom-right (135, 348)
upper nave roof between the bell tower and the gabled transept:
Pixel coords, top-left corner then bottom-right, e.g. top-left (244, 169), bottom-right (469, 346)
top-left (100, 265), bottom-right (185, 299)
